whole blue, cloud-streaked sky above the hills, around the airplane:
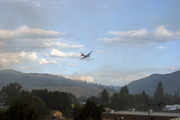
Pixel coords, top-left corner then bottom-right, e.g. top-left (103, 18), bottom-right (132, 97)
top-left (0, 0), bottom-right (180, 86)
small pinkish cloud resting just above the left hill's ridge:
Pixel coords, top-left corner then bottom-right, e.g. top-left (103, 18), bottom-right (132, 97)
top-left (66, 76), bottom-right (94, 82)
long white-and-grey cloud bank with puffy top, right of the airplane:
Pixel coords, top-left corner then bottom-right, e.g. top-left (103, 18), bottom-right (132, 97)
top-left (99, 26), bottom-right (180, 46)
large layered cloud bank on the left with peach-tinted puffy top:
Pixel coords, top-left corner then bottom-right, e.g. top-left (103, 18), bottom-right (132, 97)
top-left (0, 26), bottom-right (84, 51)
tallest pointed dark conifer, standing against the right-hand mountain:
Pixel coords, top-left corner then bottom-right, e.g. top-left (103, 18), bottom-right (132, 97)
top-left (154, 81), bottom-right (164, 102)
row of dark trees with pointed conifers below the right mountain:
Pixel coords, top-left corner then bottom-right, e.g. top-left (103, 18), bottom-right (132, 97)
top-left (79, 81), bottom-right (180, 111)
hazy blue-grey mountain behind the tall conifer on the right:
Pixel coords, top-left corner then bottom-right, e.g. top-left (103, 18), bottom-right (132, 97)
top-left (127, 71), bottom-right (180, 95)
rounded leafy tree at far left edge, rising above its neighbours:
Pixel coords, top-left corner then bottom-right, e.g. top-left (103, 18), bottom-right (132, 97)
top-left (0, 82), bottom-right (22, 104)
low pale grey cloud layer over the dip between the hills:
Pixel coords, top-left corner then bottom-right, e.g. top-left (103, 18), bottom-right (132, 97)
top-left (89, 67), bottom-right (180, 86)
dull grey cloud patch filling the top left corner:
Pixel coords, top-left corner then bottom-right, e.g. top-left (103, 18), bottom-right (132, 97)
top-left (0, 0), bottom-right (49, 29)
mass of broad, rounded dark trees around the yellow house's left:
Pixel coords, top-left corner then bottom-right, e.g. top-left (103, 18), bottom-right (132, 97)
top-left (0, 83), bottom-right (76, 120)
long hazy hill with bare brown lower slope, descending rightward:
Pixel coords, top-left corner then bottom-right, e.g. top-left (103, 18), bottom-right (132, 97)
top-left (0, 69), bottom-right (113, 97)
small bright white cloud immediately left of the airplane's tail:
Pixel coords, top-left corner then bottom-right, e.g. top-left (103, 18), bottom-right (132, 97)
top-left (49, 49), bottom-right (80, 58)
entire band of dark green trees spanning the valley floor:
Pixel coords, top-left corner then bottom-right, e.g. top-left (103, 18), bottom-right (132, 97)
top-left (0, 81), bottom-right (180, 120)
